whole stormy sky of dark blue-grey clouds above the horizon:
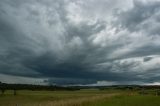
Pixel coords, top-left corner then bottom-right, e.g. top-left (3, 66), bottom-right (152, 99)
top-left (0, 0), bottom-right (160, 85)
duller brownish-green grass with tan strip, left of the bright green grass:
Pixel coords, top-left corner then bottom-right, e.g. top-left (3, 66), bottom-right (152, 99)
top-left (0, 89), bottom-right (119, 106)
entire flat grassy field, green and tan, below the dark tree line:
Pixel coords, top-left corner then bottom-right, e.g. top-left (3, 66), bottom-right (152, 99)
top-left (0, 89), bottom-right (160, 106)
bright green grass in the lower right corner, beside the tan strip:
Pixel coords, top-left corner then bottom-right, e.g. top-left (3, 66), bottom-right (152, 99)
top-left (89, 95), bottom-right (160, 106)
